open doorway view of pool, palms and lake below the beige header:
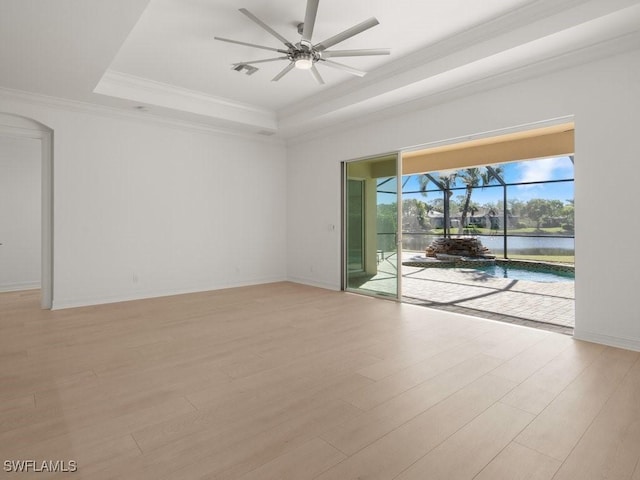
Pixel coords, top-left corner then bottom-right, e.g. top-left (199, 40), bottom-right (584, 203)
top-left (402, 156), bottom-right (575, 333)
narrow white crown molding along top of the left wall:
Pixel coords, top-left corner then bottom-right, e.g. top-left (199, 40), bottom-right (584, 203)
top-left (0, 87), bottom-right (284, 145)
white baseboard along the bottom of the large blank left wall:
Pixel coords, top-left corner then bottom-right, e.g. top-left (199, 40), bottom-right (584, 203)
top-left (51, 277), bottom-right (287, 310)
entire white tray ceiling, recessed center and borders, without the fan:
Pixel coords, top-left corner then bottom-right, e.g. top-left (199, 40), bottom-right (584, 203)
top-left (0, 0), bottom-right (640, 138)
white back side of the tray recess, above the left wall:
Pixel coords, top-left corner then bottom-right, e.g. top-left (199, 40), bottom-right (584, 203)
top-left (94, 70), bottom-right (277, 133)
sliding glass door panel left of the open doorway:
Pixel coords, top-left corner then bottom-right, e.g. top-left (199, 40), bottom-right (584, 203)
top-left (343, 154), bottom-right (402, 298)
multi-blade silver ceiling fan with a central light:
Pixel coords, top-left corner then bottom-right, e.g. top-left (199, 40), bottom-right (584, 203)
top-left (214, 0), bottom-right (391, 85)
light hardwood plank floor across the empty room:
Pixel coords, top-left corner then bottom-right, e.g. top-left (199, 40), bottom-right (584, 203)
top-left (0, 283), bottom-right (640, 480)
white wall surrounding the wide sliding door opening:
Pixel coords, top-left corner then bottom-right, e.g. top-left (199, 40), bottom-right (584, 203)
top-left (287, 47), bottom-right (640, 350)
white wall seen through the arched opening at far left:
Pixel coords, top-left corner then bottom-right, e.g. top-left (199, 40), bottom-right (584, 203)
top-left (0, 135), bottom-right (41, 292)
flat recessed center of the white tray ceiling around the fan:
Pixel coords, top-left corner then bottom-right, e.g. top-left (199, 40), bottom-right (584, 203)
top-left (106, 0), bottom-right (531, 110)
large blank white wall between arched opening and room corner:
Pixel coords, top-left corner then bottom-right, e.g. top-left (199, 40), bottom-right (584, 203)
top-left (0, 97), bottom-right (286, 308)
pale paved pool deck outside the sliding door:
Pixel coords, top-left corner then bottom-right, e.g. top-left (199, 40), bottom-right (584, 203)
top-left (361, 252), bottom-right (575, 334)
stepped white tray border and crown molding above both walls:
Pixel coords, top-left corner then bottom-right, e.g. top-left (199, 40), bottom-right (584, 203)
top-left (0, 0), bottom-right (640, 144)
